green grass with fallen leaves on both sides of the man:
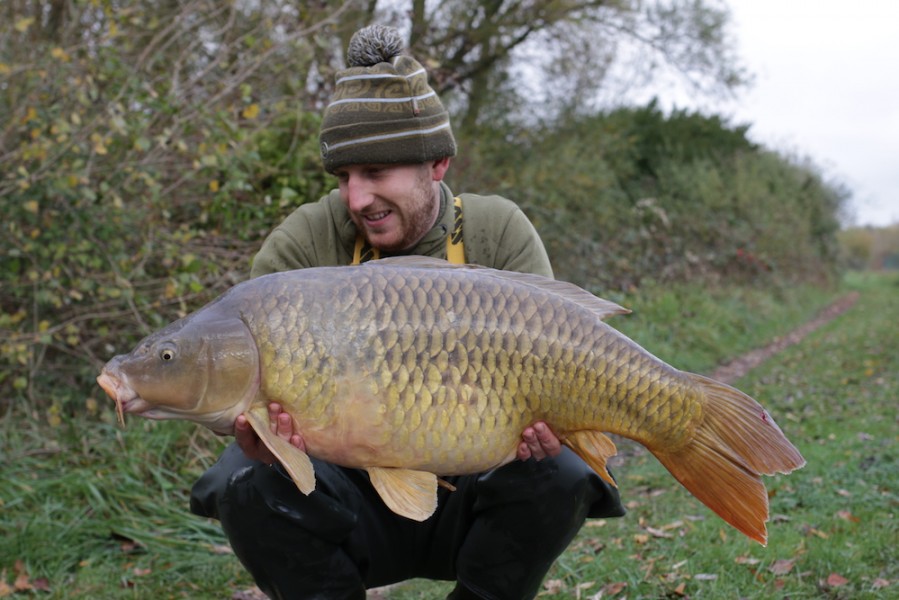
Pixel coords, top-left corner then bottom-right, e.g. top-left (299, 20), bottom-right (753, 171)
top-left (0, 275), bottom-right (899, 600)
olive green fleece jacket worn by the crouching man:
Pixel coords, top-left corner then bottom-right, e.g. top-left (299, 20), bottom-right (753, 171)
top-left (250, 183), bottom-right (553, 277)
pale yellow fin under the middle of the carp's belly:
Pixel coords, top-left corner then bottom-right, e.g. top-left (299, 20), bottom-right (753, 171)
top-left (366, 467), bottom-right (437, 521)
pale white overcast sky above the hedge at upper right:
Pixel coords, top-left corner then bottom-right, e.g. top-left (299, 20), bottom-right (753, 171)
top-left (725, 0), bottom-right (899, 226)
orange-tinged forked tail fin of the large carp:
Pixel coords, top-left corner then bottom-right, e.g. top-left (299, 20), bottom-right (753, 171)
top-left (653, 374), bottom-right (805, 545)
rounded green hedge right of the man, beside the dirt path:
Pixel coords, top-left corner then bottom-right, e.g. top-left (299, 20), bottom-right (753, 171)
top-left (455, 103), bottom-right (848, 293)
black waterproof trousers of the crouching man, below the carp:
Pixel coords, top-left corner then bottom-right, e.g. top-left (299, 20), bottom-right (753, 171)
top-left (190, 444), bottom-right (624, 600)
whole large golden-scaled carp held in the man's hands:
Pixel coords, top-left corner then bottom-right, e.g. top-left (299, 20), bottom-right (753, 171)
top-left (98, 258), bottom-right (805, 544)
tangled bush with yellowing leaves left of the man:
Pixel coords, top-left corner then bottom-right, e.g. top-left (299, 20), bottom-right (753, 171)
top-left (0, 2), bottom-right (328, 415)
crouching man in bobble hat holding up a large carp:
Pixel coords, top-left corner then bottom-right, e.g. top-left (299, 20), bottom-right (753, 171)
top-left (191, 26), bottom-right (624, 600)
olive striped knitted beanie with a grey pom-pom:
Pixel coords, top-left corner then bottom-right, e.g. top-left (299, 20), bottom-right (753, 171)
top-left (319, 25), bottom-right (456, 173)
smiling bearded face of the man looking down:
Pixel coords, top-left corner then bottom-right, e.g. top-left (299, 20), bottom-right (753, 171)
top-left (335, 162), bottom-right (448, 252)
